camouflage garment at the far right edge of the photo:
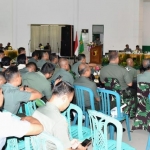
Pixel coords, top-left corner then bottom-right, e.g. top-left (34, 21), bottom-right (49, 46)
top-left (132, 82), bottom-right (150, 132)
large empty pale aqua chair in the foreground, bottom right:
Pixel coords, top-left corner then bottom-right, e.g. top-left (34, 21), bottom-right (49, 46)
top-left (88, 110), bottom-right (135, 150)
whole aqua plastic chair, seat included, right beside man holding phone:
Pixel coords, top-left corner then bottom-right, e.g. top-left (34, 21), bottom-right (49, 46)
top-left (62, 104), bottom-right (91, 142)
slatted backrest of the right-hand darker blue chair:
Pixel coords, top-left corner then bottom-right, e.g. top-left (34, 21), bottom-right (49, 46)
top-left (97, 88), bottom-right (122, 118)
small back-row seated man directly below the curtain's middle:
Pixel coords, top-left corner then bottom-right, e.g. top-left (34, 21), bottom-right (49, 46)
top-left (37, 51), bottom-right (49, 69)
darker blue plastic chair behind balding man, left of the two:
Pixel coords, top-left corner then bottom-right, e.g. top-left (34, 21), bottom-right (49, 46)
top-left (74, 85), bottom-right (95, 127)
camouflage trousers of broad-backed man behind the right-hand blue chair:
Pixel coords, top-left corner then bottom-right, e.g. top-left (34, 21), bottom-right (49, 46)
top-left (105, 78), bottom-right (136, 117)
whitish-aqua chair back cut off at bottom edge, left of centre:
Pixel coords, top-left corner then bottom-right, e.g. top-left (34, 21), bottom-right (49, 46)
top-left (31, 133), bottom-right (64, 150)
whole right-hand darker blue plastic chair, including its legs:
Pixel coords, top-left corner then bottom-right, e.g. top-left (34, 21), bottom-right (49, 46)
top-left (97, 88), bottom-right (131, 140)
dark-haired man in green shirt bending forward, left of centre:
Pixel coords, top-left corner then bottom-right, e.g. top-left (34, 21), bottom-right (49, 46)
top-left (22, 63), bottom-right (55, 100)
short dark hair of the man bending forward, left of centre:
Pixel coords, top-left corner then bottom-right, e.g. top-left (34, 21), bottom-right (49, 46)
top-left (41, 63), bottom-right (55, 74)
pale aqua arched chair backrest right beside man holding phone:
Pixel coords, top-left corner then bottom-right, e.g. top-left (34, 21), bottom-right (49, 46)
top-left (62, 104), bottom-right (83, 139)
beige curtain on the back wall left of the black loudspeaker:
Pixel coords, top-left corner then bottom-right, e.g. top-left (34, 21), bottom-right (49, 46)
top-left (31, 25), bottom-right (61, 53)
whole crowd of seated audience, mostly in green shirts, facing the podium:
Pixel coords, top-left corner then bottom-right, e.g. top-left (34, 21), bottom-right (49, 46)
top-left (0, 43), bottom-right (150, 149)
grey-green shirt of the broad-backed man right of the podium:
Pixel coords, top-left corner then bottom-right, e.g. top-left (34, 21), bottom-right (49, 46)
top-left (100, 63), bottom-right (132, 90)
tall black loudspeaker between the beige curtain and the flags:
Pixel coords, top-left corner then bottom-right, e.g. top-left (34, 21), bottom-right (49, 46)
top-left (60, 25), bottom-right (73, 56)
